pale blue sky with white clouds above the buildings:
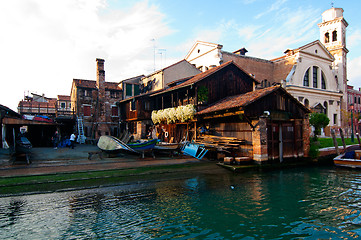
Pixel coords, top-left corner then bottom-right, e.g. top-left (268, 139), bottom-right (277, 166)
top-left (0, 0), bottom-right (361, 111)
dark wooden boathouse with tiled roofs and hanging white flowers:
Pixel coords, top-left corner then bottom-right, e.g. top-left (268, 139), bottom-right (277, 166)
top-left (118, 61), bottom-right (310, 162)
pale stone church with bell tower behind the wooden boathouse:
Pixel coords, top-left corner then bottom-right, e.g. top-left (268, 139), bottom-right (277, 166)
top-left (185, 8), bottom-right (348, 135)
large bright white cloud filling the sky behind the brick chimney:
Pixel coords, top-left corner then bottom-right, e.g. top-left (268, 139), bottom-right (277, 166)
top-left (0, 0), bottom-right (172, 110)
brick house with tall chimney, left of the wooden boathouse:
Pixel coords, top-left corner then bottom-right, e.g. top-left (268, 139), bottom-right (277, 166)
top-left (70, 59), bottom-right (122, 139)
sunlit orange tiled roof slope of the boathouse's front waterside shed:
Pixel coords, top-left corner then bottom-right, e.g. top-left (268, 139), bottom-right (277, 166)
top-left (197, 86), bottom-right (281, 115)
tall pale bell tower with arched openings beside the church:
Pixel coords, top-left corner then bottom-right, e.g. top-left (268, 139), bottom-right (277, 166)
top-left (318, 7), bottom-right (348, 123)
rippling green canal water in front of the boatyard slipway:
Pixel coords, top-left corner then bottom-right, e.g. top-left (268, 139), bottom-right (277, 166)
top-left (0, 166), bottom-right (361, 240)
